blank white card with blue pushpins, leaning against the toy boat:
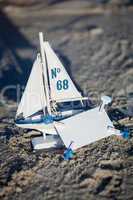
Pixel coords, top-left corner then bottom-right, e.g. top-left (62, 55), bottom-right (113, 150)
top-left (55, 107), bottom-right (114, 149)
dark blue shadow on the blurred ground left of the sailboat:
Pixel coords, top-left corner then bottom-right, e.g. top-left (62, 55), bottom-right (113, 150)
top-left (0, 10), bottom-right (35, 99)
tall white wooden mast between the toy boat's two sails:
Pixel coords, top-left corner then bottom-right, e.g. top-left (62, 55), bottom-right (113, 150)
top-left (39, 32), bottom-right (51, 115)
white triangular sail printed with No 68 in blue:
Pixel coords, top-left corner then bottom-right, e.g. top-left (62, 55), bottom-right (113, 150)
top-left (44, 42), bottom-right (82, 102)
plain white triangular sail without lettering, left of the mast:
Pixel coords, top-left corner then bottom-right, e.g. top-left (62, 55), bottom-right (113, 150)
top-left (17, 56), bottom-right (46, 118)
